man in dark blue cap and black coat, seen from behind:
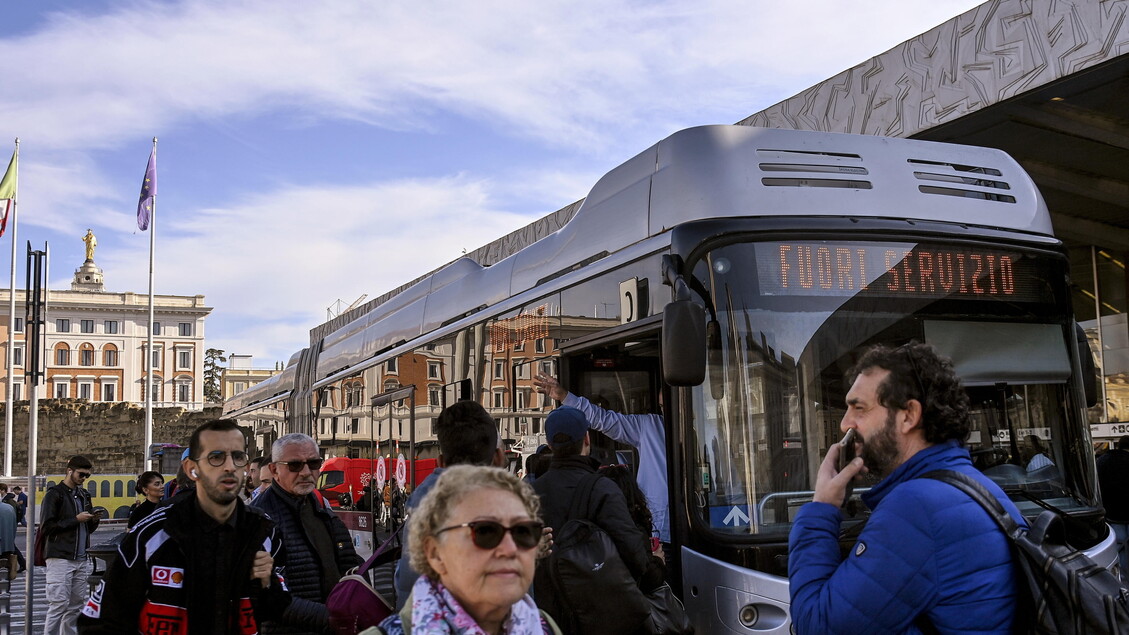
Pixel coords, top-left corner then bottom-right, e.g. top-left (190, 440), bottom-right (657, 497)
top-left (533, 407), bottom-right (649, 625)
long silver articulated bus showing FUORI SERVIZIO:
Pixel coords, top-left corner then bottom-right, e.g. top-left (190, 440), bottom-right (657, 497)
top-left (226, 125), bottom-right (1115, 633)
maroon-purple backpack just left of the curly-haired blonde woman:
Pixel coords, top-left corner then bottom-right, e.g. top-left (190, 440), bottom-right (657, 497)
top-left (325, 525), bottom-right (403, 635)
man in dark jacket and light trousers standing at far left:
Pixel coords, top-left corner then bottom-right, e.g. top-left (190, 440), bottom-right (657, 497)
top-left (40, 455), bottom-right (100, 635)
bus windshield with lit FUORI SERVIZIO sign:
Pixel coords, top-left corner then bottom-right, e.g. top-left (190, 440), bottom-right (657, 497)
top-left (690, 241), bottom-right (1096, 539)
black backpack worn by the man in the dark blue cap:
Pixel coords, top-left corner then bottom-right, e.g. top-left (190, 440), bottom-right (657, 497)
top-left (548, 473), bottom-right (650, 633)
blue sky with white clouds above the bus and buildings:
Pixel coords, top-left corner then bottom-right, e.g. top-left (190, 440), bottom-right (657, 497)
top-left (0, 0), bottom-right (979, 367)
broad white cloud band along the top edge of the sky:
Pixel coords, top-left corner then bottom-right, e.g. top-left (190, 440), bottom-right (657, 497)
top-left (0, 0), bottom-right (973, 152)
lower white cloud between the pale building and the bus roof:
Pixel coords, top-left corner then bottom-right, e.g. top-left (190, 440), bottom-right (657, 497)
top-left (90, 176), bottom-right (532, 358)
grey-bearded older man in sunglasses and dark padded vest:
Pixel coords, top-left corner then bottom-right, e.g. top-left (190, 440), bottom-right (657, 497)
top-left (254, 433), bottom-right (364, 635)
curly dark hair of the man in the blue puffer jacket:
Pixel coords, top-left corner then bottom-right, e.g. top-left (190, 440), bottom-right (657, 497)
top-left (848, 341), bottom-right (969, 445)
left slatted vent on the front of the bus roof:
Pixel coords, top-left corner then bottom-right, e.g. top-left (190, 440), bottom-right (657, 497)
top-left (756, 149), bottom-right (873, 190)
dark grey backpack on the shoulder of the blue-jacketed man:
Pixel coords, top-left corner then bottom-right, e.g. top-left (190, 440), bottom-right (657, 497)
top-left (922, 470), bottom-right (1129, 635)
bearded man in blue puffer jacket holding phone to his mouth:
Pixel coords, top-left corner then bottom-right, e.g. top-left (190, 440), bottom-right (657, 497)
top-left (788, 342), bottom-right (1024, 634)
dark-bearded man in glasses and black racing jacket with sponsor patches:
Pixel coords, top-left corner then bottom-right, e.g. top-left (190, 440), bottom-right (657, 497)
top-left (79, 419), bottom-right (290, 635)
